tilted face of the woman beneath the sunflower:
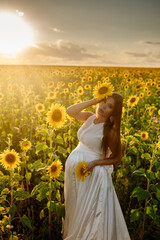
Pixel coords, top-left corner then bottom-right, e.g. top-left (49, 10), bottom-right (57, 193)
top-left (96, 97), bottom-right (114, 119)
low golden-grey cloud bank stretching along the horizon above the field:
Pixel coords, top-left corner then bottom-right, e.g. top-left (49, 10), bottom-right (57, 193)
top-left (0, 39), bottom-right (160, 67)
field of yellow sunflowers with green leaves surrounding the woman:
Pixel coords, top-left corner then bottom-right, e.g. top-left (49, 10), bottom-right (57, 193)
top-left (0, 65), bottom-right (160, 240)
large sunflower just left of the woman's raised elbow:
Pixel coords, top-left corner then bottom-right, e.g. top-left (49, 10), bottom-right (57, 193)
top-left (47, 103), bottom-right (66, 128)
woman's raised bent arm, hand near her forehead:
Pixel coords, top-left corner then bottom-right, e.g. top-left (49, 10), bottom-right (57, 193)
top-left (66, 98), bottom-right (100, 121)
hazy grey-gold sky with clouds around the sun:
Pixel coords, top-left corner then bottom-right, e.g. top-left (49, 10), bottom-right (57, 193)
top-left (0, 0), bottom-right (160, 68)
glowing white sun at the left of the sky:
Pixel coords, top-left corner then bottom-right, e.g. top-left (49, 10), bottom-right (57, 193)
top-left (0, 12), bottom-right (33, 54)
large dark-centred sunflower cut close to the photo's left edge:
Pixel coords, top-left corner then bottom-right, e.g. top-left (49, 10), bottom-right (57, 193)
top-left (0, 149), bottom-right (20, 169)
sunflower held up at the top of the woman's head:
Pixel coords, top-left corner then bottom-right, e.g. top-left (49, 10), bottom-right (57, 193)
top-left (93, 82), bottom-right (114, 100)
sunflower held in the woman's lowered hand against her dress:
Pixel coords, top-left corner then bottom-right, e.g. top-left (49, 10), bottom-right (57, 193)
top-left (75, 161), bottom-right (90, 181)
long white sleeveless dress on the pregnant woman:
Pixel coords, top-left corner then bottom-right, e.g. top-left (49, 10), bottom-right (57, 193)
top-left (62, 114), bottom-right (130, 240)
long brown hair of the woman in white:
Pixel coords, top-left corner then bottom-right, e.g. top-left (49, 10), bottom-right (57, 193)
top-left (101, 92), bottom-right (123, 158)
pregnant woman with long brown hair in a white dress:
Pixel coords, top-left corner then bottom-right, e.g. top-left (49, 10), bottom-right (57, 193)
top-left (62, 92), bottom-right (130, 240)
